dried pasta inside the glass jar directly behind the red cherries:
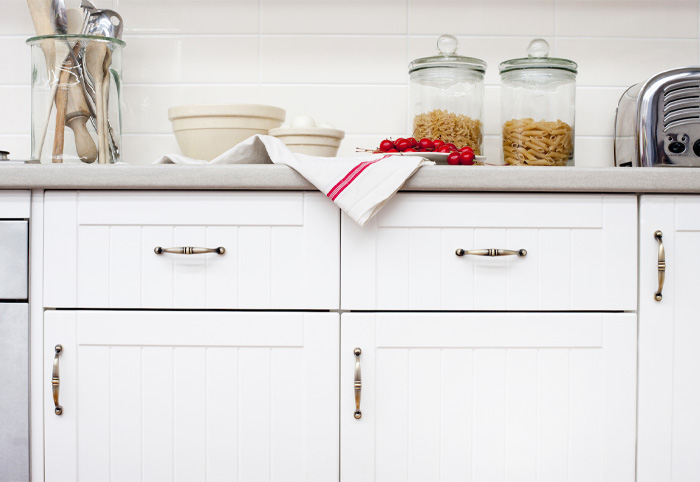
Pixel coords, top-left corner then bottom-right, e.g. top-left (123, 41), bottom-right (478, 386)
top-left (413, 109), bottom-right (482, 156)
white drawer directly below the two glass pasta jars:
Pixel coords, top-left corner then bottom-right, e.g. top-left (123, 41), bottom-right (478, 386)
top-left (341, 193), bottom-right (637, 311)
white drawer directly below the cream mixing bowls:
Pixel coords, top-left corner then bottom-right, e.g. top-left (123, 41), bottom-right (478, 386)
top-left (44, 191), bottom-right (340, 309)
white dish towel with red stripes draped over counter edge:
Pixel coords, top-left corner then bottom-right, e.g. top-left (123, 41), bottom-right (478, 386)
top-left (155, 135), bottom-right (435, 226)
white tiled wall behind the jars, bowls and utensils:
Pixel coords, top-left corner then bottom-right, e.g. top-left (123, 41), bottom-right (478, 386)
top-left (0, 0), bottom-right (700, 166)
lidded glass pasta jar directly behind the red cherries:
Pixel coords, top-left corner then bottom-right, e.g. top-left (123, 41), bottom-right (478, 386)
top-left (408, 35), bottom-right (486, 155)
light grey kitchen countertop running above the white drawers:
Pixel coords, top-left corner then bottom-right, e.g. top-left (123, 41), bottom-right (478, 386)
top-left (0, 164), bottom-right (700, 193)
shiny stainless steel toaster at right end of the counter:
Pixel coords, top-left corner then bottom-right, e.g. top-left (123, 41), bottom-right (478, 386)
top-left (615, 67), bottom-right (700, 167)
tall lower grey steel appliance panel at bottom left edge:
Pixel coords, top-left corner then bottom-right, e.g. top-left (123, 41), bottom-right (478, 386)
top-left (0, 304), bottom-right (29, 482)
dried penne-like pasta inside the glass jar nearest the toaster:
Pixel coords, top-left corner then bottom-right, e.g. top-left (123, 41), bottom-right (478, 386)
top-left (503, 118), bottom-right (574, 166)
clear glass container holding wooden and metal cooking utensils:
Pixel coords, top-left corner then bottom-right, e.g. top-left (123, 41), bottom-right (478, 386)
top-left (27, 35), bottom-right (125, 164)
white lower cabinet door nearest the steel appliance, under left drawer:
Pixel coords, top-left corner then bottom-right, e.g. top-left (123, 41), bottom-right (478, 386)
top-left (44, 311), bottom-right (339, 482)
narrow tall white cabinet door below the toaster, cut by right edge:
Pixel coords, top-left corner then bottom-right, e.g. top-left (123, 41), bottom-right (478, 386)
top-left (637, 196), bottom-right (700, 482)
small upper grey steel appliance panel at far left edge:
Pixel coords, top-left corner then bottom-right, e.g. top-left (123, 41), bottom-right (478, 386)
top-left (0, 221), bottom-right (29, 298)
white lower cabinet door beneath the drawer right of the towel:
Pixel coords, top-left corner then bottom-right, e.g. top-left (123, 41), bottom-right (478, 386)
top-left (340, 313), bottom-right (636, 482)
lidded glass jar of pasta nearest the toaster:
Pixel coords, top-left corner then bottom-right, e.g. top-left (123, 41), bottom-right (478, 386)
top-left (499, 39), bottom-right (578, 166)
